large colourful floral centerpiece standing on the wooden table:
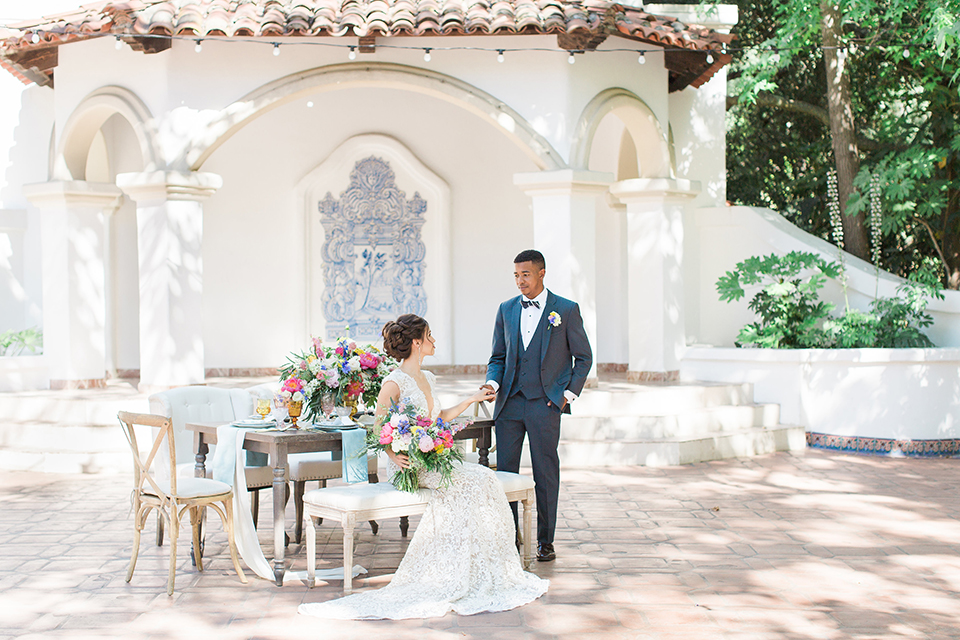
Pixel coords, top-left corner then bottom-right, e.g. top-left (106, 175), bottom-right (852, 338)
top-left (280, 338), bottom-right (397, 418)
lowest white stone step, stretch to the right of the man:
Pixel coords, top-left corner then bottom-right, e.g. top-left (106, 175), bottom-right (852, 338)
top-left (559, 425), bottom-right (806, 467)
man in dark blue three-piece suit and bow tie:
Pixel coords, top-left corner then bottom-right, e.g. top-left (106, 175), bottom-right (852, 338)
top-left (484, 249), bottom-right (593, 562)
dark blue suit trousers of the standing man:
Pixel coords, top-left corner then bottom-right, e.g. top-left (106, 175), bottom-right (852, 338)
top-left (496, 393), bottom-right (560, 544)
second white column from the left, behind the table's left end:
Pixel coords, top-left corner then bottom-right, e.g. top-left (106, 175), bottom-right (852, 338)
top-left (117, 171), bottom-right (223, 391)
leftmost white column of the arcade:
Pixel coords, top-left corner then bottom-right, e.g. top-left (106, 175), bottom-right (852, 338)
top-left (23, 181), bottom-right (123, 389)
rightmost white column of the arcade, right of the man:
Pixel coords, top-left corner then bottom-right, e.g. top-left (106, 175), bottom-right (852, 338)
top-left (610, 178), bottom-right (700, 382)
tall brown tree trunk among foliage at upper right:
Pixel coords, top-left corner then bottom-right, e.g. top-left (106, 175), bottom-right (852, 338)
top-left (820, 0), bottom-right (870, 261)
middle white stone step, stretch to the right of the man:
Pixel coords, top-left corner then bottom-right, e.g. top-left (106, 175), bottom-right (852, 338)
top-left (560, 404), bottom-right (780, 441)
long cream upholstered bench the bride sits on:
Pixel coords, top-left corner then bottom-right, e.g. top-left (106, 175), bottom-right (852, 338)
top-left (303, 471), bottom-right (535, 594)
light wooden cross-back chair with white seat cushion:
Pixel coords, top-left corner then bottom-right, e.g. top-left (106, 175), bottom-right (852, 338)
top-left (117, 411), bottom-right (247, 595)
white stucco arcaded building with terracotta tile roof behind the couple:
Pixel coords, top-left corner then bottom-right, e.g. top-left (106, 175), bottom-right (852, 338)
top-left (0, 1), bottom-right (735, 388)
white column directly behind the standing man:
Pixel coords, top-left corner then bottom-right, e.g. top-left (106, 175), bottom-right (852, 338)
top-left (513, 169), bottom-right (613, 384)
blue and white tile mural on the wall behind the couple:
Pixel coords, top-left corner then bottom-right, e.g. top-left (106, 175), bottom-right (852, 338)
top-left (319, 156), bottom-right (427, 340)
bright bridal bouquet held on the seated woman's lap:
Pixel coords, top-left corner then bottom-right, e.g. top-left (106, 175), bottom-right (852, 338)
top-left (367, 398), bottom-right (470, 493)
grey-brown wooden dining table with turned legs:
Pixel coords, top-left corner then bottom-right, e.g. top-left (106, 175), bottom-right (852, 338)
top-left (186, 419), bottom-right (493, 587)
